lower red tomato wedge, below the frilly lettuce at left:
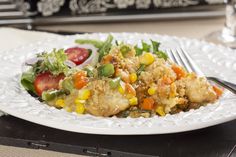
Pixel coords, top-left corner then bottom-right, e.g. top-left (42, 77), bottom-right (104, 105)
top-left (34, 72), bottom-right (65, 96)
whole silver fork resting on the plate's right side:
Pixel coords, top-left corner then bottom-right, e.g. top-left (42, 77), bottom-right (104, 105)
top-left (167, 48), bottom-right (236, 94)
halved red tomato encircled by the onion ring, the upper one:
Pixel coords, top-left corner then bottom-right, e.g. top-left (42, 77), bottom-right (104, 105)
top-left (65, 47), bottom-right (89, 65)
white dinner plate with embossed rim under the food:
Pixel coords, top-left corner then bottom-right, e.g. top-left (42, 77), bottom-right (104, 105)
top-left (0, 33), bottom-right (236, 135)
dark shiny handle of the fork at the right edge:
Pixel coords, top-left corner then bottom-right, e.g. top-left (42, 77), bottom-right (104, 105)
top-left (207, 77), bottom-right (236, 94)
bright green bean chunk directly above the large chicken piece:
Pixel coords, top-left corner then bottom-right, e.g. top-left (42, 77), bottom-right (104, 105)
top-left (98, 64), bottom-right (115, 77)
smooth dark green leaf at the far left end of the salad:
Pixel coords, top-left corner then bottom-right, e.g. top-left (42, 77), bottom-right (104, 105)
top-left (21, 70), bottom-right (36, 93)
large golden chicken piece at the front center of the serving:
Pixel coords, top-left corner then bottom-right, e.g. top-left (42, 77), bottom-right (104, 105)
top-left (85, 79), bottom-right (129, 117)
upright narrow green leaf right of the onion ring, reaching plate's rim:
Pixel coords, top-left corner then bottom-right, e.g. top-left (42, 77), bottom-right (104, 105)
top-left (98, 35), bottom-right (113, 61)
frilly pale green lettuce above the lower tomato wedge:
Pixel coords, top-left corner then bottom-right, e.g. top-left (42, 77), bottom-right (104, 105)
top-left (36, 49), bottom-right (69, 75)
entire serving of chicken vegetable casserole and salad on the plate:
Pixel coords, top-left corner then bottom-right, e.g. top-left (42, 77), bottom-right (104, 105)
top-left (21, 35), bottom-right (222, 117)
